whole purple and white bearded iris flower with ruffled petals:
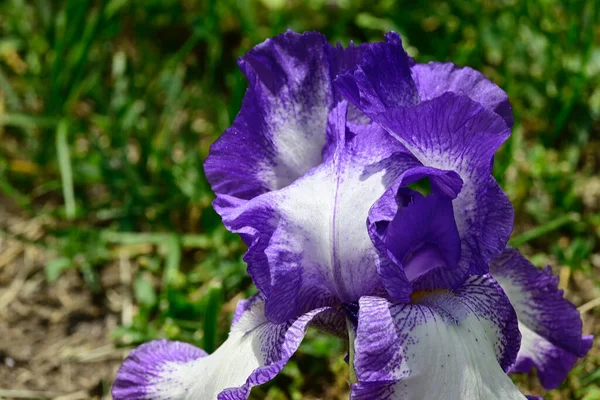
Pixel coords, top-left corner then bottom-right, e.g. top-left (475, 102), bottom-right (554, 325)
top-left (113, 31), bottom-right (592, 400)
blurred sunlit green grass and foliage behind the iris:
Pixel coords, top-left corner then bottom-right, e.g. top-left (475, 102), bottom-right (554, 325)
top-left (0, 0), bottom-right (600, 400)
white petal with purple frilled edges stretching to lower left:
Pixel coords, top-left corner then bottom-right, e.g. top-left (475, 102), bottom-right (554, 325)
top-left (112, 299), bottom-right (337, 400)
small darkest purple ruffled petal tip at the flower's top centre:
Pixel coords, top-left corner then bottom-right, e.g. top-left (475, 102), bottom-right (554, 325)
top-left (336, 32), bottom-right (419, 116)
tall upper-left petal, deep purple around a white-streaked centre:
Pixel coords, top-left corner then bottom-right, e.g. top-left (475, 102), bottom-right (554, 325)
top-left (204, 31), bottom-right (334, 199)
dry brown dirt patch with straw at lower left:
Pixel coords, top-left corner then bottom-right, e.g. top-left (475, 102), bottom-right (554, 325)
top-left (0, 209), bottom-right (126, 400)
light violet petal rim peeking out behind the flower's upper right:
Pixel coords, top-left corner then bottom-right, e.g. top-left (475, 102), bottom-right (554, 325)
top-left (410, 62), bottom-right (514, 127)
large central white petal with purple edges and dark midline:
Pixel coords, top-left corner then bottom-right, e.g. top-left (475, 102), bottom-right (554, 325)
top-left (220, 102), bottom-right (419, 321)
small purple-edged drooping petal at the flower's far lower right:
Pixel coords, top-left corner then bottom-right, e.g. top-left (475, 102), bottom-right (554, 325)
top-left (490, 248), bottom-right (592, 389)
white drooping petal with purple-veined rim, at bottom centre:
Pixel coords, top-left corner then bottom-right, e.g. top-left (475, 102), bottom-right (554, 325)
top-left (351, 275), bottom-right (525, 400)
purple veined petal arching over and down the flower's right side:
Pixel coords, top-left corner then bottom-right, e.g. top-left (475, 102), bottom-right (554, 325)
top-left (375, 93), bottom-right (513, 274)
